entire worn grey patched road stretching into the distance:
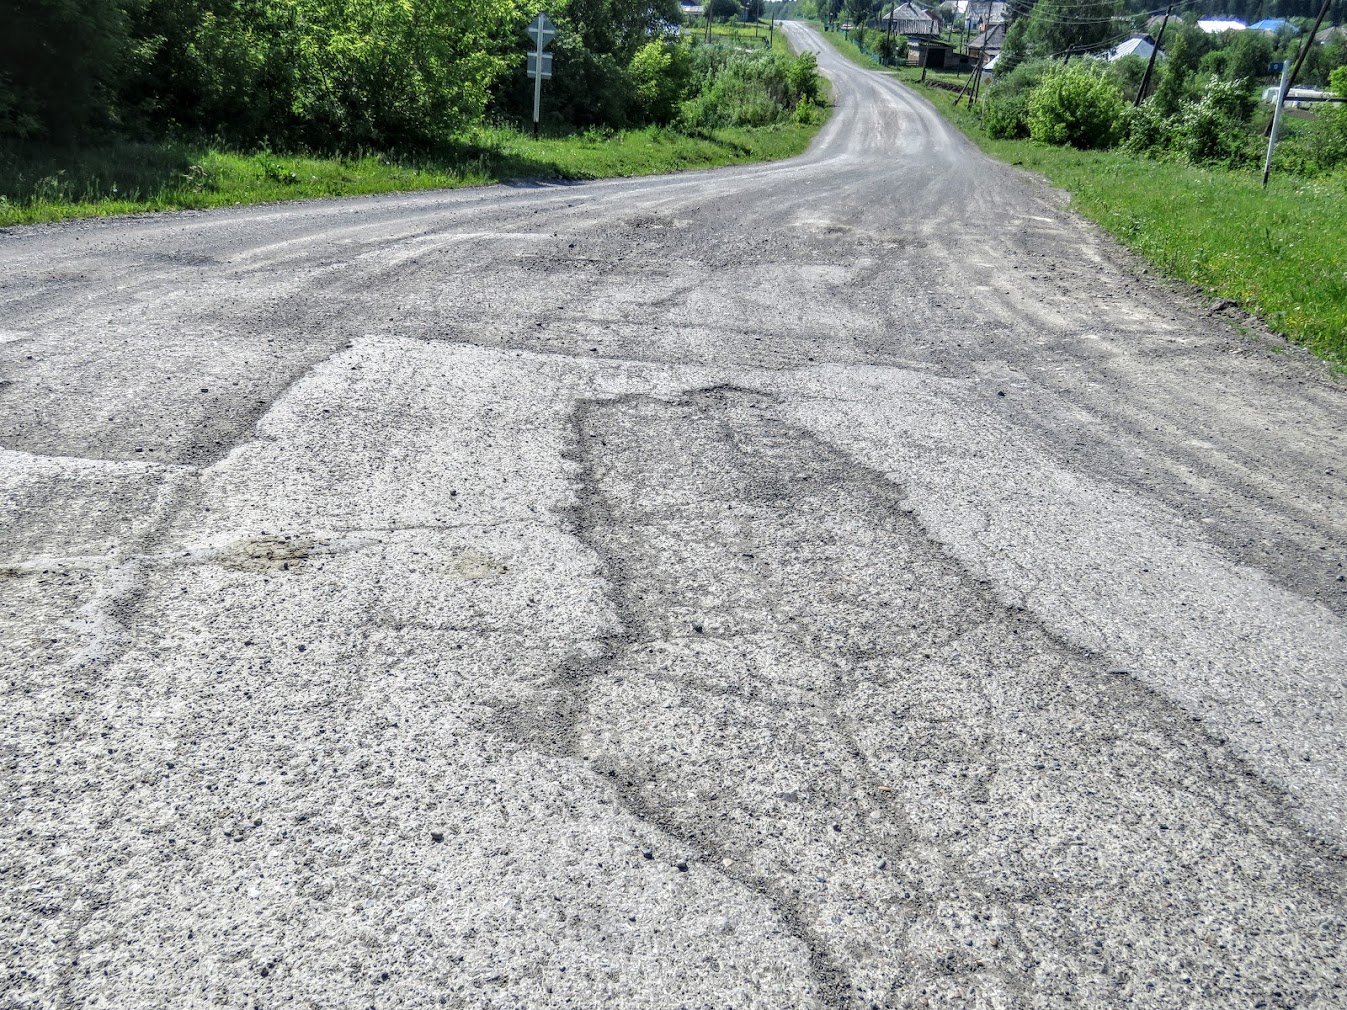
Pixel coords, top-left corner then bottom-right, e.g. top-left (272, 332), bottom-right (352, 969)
top-left (0, 26), bottom-right (1347, 1010)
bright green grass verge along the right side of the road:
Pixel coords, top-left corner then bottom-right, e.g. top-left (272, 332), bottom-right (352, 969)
top-left (828, 24), bottom-right (1347, 368)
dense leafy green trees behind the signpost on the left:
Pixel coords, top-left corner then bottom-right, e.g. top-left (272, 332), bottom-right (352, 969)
top-left (0, 0), bottom-right (770, 149)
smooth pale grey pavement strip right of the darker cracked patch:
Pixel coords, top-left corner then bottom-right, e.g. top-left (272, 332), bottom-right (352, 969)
top-left (789, 368), bottom-right (1347, 843)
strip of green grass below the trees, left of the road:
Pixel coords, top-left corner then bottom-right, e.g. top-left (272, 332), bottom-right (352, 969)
top-left (0, 124), bottom-right (819, 226)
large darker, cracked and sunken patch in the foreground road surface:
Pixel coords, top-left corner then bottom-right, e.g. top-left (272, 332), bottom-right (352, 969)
top-left (500, 386), bottom-right (1347, 1010)
